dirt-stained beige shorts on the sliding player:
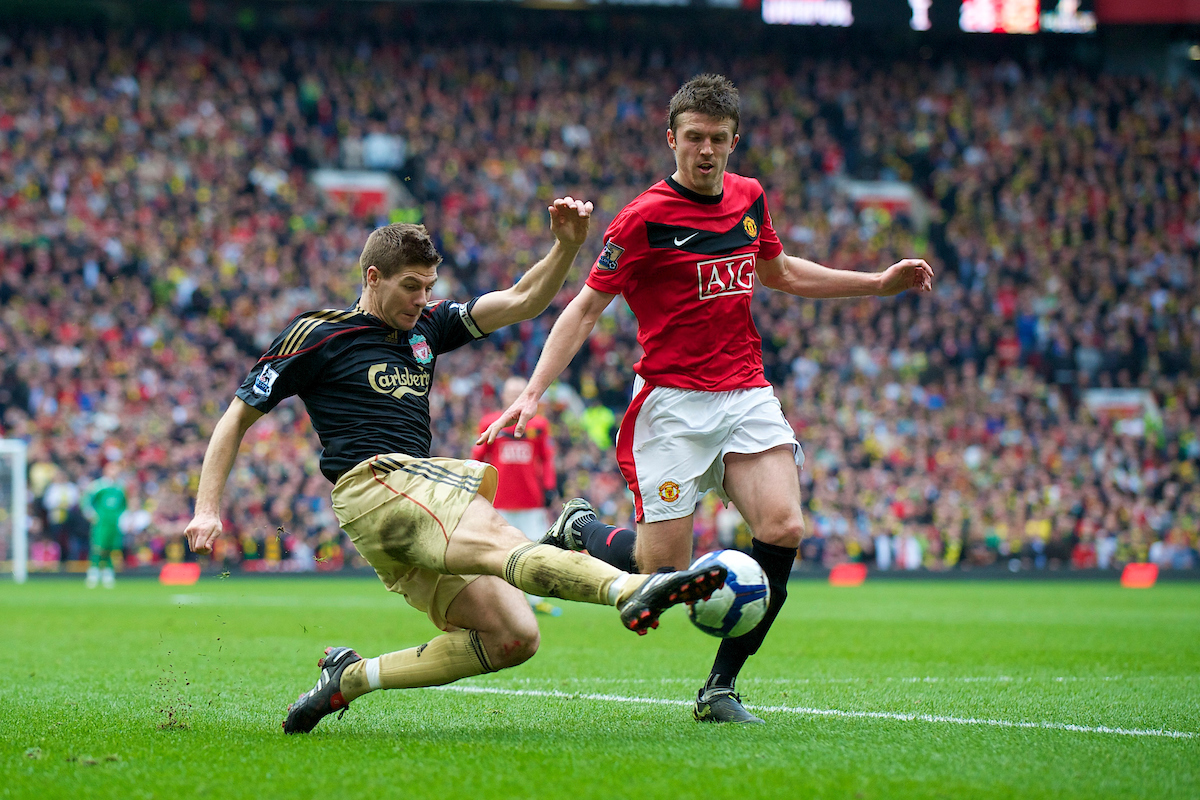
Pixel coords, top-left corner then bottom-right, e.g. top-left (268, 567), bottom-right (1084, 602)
top-left (334, 453), bottom-right (497, 631)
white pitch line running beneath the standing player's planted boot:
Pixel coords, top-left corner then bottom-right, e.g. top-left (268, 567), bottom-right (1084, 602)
top-left (430, 686), bottom-right (1200, 739)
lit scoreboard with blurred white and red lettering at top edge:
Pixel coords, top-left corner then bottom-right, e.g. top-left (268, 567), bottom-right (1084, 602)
top-left (762, 0), bottom-right (1096, 34)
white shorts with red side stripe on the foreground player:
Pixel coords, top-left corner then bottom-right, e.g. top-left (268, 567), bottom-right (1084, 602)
top-left (617, 377), bottom-right (804, 522)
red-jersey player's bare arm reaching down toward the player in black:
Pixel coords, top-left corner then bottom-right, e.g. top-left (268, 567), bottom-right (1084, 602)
top-left (475, 285), bottom-right (617, 444)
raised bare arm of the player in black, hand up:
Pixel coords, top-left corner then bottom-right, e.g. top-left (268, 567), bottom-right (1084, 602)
top-left (470, 197), bottom-right (592, 333)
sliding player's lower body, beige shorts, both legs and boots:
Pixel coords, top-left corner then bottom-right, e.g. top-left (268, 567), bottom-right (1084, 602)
top-left (283, 455), bottom-right (725, 733)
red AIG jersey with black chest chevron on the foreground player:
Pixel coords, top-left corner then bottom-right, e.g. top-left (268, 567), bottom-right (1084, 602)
top-left (588, 173), bottom-right (784, 392)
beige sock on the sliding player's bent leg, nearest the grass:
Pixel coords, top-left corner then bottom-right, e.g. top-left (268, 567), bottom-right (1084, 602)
top-left (342, 631), bottom-right (496, 703)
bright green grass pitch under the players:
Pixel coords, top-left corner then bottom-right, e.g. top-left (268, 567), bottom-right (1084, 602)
top-left (0, 577), bottom-right (1200, 800)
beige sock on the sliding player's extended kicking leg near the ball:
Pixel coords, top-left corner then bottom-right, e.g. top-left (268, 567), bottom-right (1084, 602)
top-left (504, 543), bottom-right (646, 606)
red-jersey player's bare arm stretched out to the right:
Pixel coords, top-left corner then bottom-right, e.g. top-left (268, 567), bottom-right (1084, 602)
top-left (756, 253), bottom-right (934, 299)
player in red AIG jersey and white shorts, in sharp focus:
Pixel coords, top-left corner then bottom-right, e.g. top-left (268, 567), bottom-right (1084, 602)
top-left (480, 76), bottom-right (934, 722)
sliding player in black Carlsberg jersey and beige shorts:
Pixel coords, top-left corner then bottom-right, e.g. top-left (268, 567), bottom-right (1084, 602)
top-left (185, 197), bottom-right (725, 733)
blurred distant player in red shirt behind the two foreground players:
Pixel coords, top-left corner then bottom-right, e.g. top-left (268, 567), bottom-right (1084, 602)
top-left (470, 375), bottom-right (563, 616)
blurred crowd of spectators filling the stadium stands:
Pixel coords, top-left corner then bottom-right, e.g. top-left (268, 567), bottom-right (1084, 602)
top-left (0, 23), bottom-right (1200, 570)
